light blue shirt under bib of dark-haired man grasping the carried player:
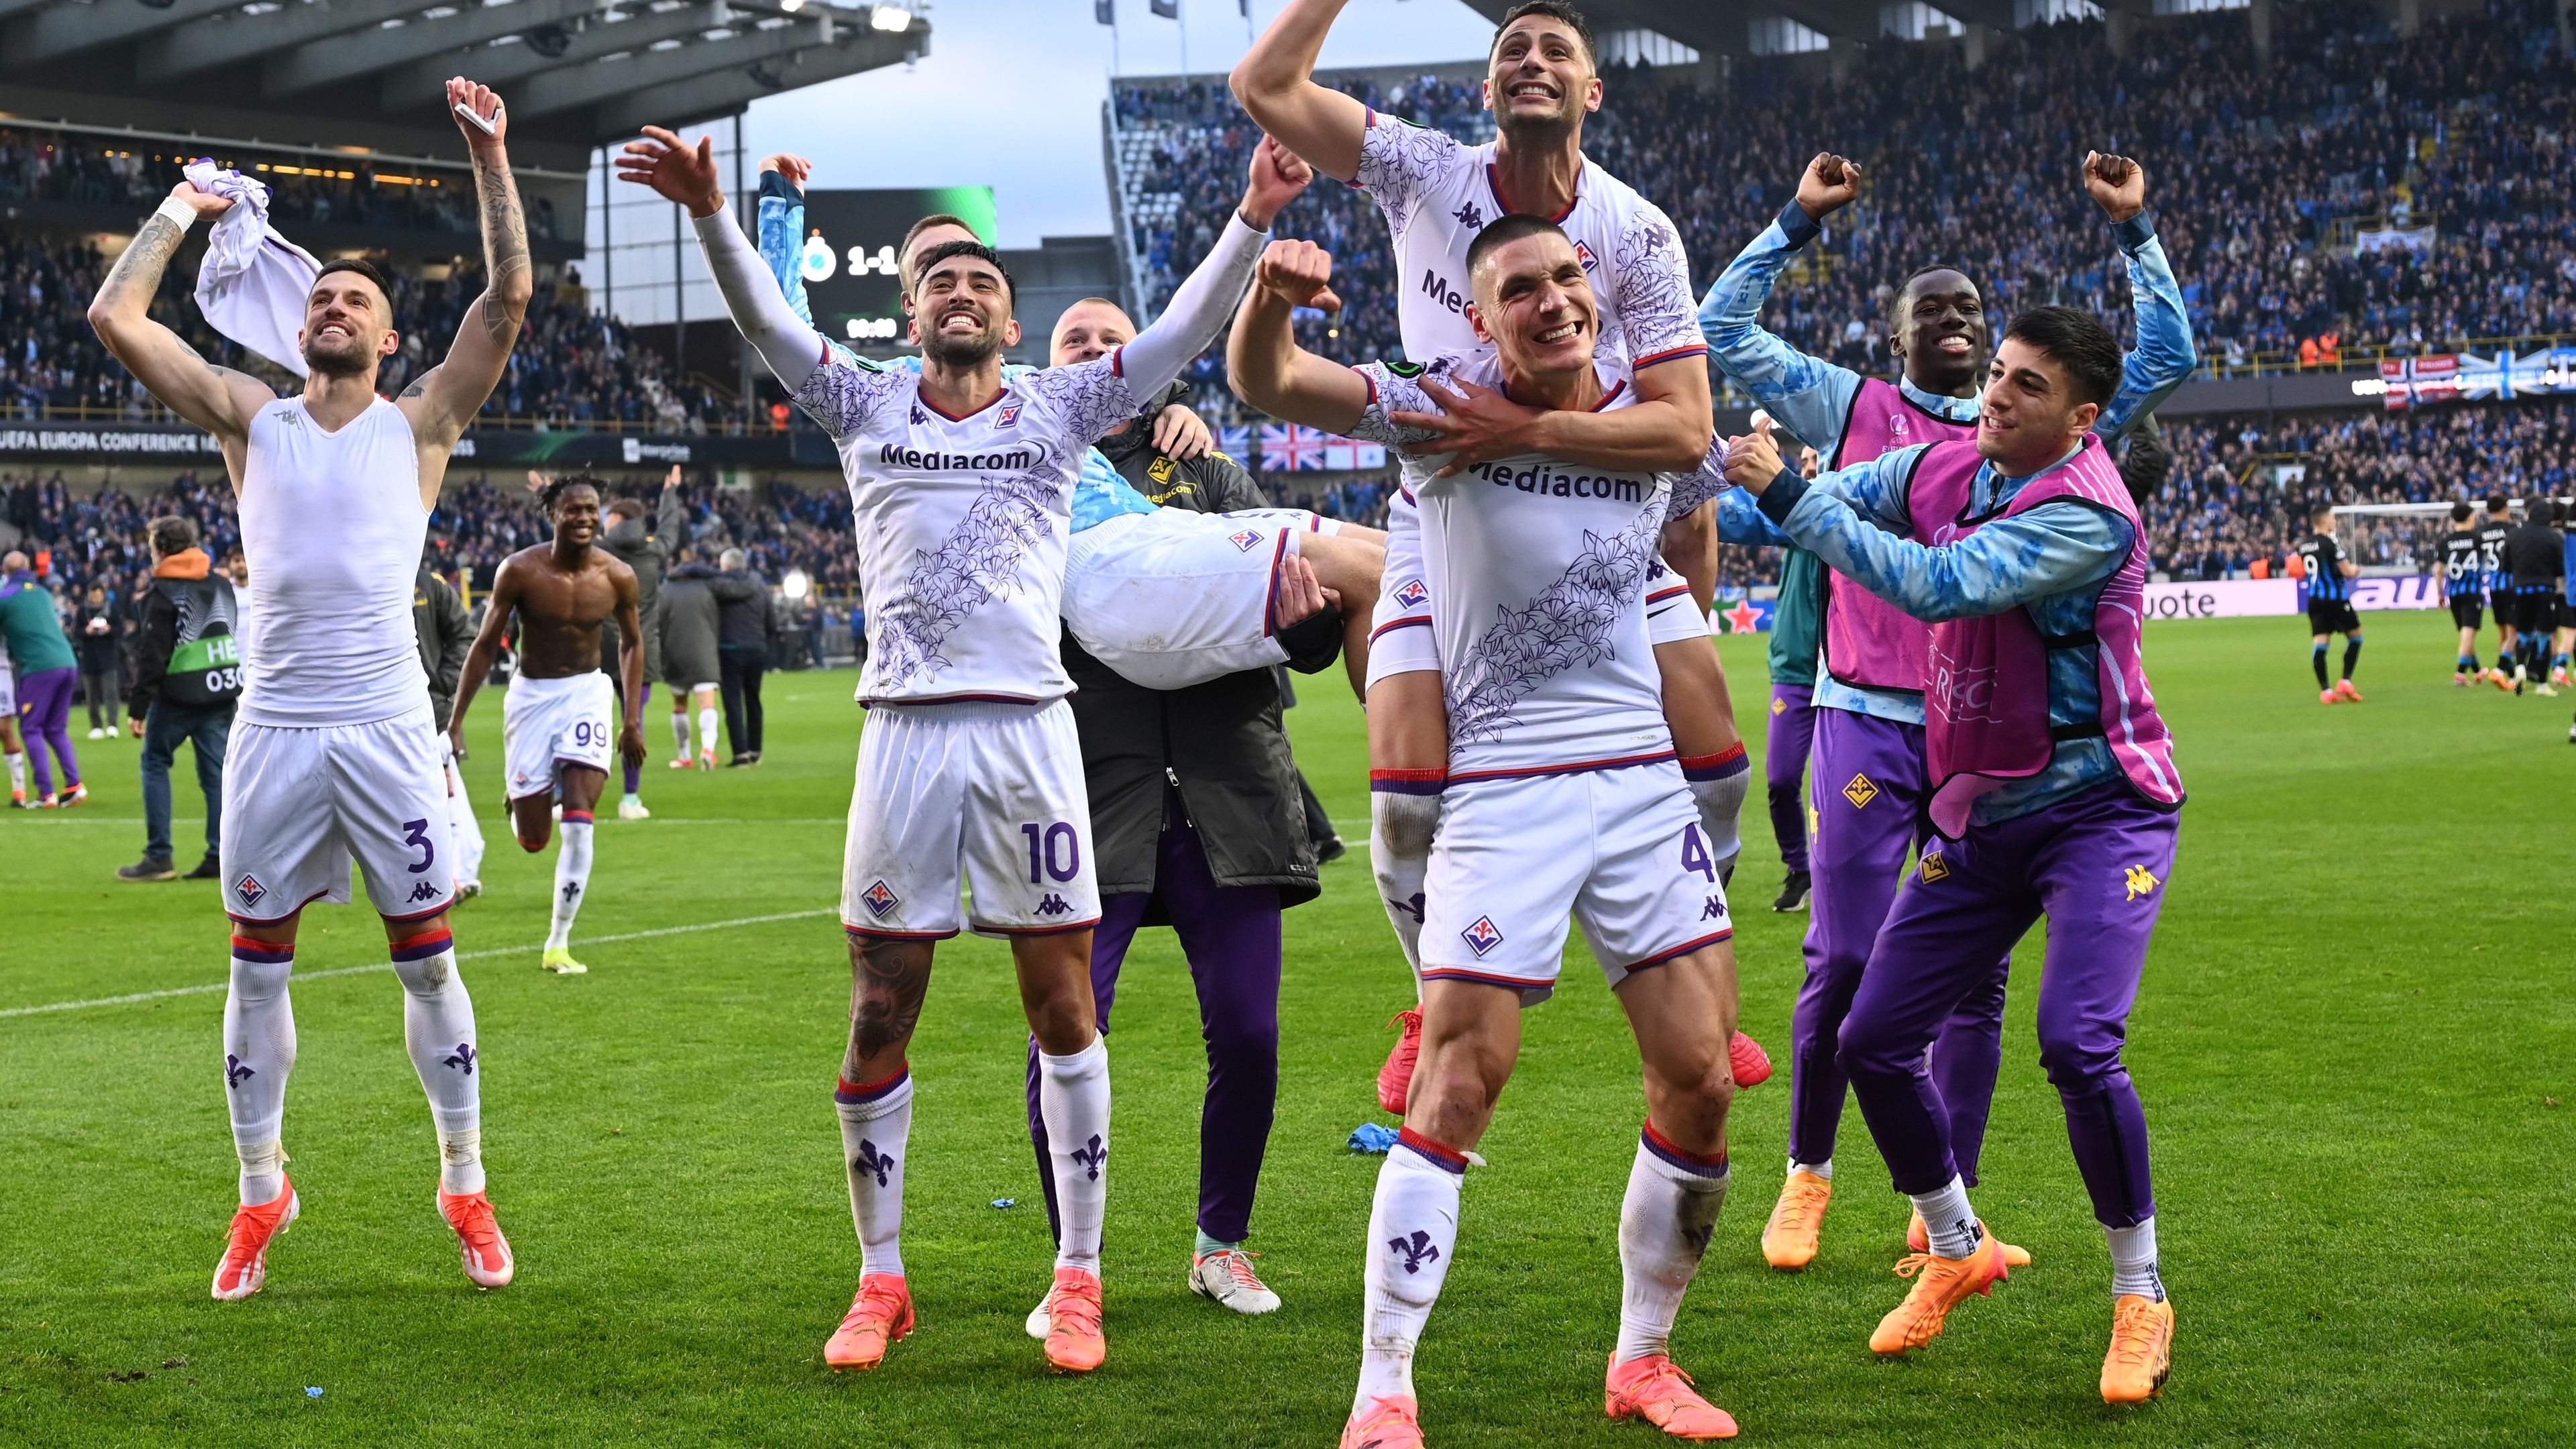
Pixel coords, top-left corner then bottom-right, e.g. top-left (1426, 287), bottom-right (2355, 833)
top-left (1760, 443), bottom-right (2135, 825)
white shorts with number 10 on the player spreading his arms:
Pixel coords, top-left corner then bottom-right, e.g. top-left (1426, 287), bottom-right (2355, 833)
top-left (840, 699), bottom-right (1100, 941)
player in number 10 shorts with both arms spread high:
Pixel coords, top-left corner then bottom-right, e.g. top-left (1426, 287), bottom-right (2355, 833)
top-left (619, 129), bottom-right (1311, 1372)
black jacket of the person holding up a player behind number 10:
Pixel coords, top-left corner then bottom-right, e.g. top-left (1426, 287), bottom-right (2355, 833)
top-left (1064, 425), bottom-right (1342, 902)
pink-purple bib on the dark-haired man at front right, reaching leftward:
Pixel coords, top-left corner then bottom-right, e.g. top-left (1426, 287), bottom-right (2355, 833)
top-left (1907, 433), bottom-right (2182, 841)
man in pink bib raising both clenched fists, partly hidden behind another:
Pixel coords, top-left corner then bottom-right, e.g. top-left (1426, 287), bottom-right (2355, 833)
top-left (1700, 152), bottom-right (2195, 1271)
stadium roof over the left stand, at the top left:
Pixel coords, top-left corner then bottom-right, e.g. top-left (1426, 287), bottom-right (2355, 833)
top-left (0, 0), bottom-right (930, 165)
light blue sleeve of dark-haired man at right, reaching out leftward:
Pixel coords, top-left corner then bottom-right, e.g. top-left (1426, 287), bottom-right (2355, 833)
top-left (1762, 470), bottom-right (2133, 624)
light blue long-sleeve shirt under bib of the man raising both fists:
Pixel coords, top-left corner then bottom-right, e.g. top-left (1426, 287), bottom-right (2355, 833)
top-left (1700, 201), bottom-right (2200, 724)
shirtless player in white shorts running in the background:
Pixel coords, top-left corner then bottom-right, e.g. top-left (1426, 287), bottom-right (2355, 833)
top-left (448, 474), bottom-right (644, 975)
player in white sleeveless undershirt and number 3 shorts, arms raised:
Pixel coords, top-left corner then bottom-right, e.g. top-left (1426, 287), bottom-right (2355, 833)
top-left (90, 77), bottom-right (536, 1299)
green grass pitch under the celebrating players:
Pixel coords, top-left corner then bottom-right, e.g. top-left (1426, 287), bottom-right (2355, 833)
top-left (0, 603), bottom-right (2576, 1449)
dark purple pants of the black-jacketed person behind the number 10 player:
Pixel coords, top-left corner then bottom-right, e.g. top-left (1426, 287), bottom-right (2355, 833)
top-left (1028, 802), bottom-right (1280, 1243)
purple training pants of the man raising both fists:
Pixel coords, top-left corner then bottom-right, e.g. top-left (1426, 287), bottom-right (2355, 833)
top-left (1788, 706), bottom-right (2015, 1186)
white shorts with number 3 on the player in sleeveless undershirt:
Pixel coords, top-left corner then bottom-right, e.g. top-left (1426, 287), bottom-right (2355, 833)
top-left (224, 696), bottom-right (456, 923)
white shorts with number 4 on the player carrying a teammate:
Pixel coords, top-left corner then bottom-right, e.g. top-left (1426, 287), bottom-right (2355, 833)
top-left (1422, 755), bottom-right (1733, 1006)
